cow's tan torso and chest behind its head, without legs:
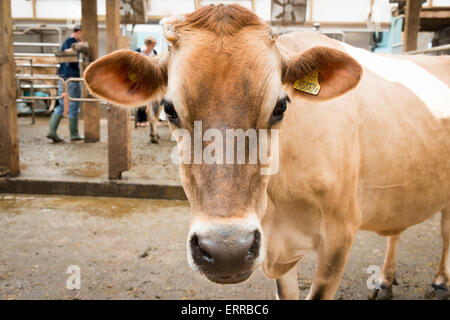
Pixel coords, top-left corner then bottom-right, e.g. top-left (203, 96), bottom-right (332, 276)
top-left (263, 33), bottom-right (450, 298)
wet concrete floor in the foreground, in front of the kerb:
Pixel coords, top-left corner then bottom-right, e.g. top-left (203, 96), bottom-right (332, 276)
top-left (0, 194), bottom-right (441, 299)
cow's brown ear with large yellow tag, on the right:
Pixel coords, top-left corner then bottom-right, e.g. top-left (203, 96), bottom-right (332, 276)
top-left (283, 47), bottom-right (363, 100)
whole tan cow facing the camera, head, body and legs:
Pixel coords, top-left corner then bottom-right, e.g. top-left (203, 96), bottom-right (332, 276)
top-left (85, 5), bottom-right (450, 299)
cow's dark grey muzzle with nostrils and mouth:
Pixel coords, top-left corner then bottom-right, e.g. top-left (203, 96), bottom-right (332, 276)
top-left (190, 229), bottom-right (261, 283)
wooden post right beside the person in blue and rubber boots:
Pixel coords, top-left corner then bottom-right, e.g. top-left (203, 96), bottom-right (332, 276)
top-left (81, 0), bottom-right (100, 142)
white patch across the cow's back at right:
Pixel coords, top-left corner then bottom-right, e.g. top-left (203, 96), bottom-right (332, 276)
top-left (341, 43), bottom-right (450, 119)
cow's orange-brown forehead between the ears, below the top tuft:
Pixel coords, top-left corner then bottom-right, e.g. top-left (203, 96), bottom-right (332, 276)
top-left (169, 31), bottom-right (281, 127)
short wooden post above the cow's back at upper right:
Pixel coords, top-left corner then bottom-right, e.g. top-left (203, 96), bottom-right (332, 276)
top-left (403, 0), bottom-right (422, 52)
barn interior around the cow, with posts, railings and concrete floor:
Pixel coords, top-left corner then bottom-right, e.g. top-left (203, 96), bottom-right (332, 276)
top-left (0, 0), bottom-right (450, 300)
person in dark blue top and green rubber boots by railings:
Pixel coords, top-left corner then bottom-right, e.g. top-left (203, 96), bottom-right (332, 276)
top-left (47, 26), bottom-right (86, 142)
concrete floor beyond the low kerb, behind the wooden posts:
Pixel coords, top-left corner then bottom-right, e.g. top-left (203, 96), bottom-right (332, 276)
top-left (18, 117), bottom-right (180, 185)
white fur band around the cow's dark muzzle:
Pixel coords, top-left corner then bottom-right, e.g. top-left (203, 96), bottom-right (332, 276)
top-left (186, 214), bottom-right (266, 272)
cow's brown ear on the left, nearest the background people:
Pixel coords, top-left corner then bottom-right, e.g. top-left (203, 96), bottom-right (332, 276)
top-left (84, 50), bottom-right (167, 106)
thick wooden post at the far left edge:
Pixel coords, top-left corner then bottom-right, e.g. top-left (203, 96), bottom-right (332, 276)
top-left (0, 0), bottom-right (20, 177)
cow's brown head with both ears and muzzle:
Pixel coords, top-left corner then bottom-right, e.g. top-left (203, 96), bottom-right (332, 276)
top-left (85, 5), bottom-right (361, 283)
